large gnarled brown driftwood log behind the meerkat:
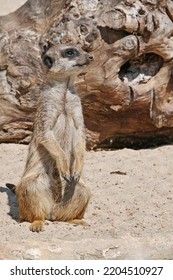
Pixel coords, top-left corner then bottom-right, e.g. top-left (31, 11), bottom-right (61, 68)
top-left (0, 0), bottom-right (173, 148)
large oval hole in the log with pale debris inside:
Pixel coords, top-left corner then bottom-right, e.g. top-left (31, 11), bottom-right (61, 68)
top-left (119, 53), bottom-right (163, 84)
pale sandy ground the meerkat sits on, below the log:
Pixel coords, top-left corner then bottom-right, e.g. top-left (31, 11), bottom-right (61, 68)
top-left (0, 144), bottom-right (173, 259)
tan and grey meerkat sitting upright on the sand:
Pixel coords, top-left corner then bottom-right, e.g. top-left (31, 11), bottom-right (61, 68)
top-left (15, 45), bottom-right (93, 232)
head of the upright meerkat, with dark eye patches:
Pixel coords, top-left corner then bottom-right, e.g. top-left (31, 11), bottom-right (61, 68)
top-left (42, 45), bottom-right (93, 79)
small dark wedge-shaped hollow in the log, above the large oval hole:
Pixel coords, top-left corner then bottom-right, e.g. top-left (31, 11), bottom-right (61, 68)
top-left (98, 26), bottom-right (130, 44)
